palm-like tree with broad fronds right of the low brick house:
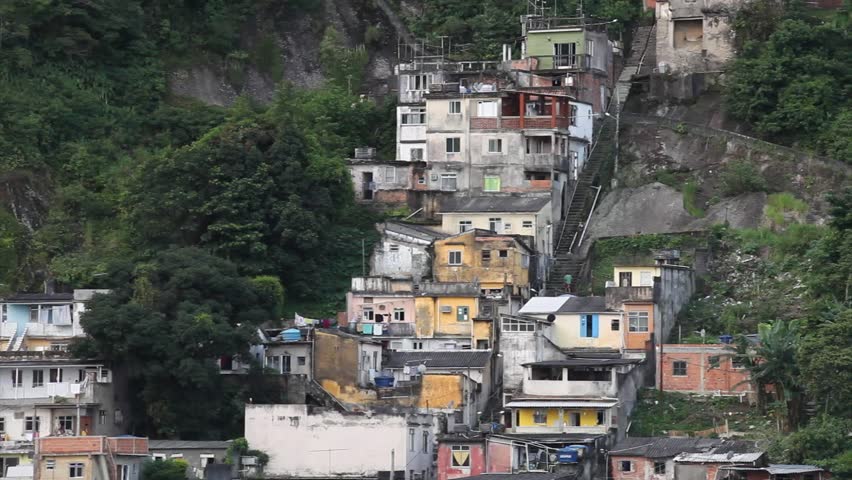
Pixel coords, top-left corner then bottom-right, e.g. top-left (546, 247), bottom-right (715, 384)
top-left (748, 320), bottom-right (802, 429)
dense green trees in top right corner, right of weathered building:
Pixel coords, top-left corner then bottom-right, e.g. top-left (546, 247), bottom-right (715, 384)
top-left (726, 0), bottom-right (852, 162)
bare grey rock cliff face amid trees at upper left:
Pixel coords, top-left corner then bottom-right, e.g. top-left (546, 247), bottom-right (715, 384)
top-left (168, 0), bottom-right (407, 106)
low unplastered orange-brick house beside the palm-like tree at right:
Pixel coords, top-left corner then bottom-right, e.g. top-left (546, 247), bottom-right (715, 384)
top-left (657, 344), bottom-right (755, 395)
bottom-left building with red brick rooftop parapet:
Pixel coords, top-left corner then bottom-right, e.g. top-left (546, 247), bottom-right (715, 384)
top-left (34, 436), bottom-right (149, 480)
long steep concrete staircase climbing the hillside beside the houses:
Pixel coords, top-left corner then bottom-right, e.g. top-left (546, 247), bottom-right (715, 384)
top-left (545, 25), bottom-right (656, 296)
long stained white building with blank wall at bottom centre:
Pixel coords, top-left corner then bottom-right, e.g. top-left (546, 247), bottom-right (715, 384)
top-left (245, 404), bottom-right (436, 480)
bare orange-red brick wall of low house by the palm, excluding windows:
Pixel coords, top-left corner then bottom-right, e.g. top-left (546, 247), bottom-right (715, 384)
top-left (660, 345), bottom-right (752, 395)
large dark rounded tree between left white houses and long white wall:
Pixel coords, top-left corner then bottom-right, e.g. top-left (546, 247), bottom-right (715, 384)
top-left (75, 248), bottom-right (276, 438)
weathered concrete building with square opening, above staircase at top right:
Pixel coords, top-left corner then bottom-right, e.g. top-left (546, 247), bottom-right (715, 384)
top-left (655, 0), bottom-right (743, 73)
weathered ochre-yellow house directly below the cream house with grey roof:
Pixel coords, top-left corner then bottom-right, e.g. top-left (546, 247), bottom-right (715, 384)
top-left (432, 229), bottom-right (533, 297)
